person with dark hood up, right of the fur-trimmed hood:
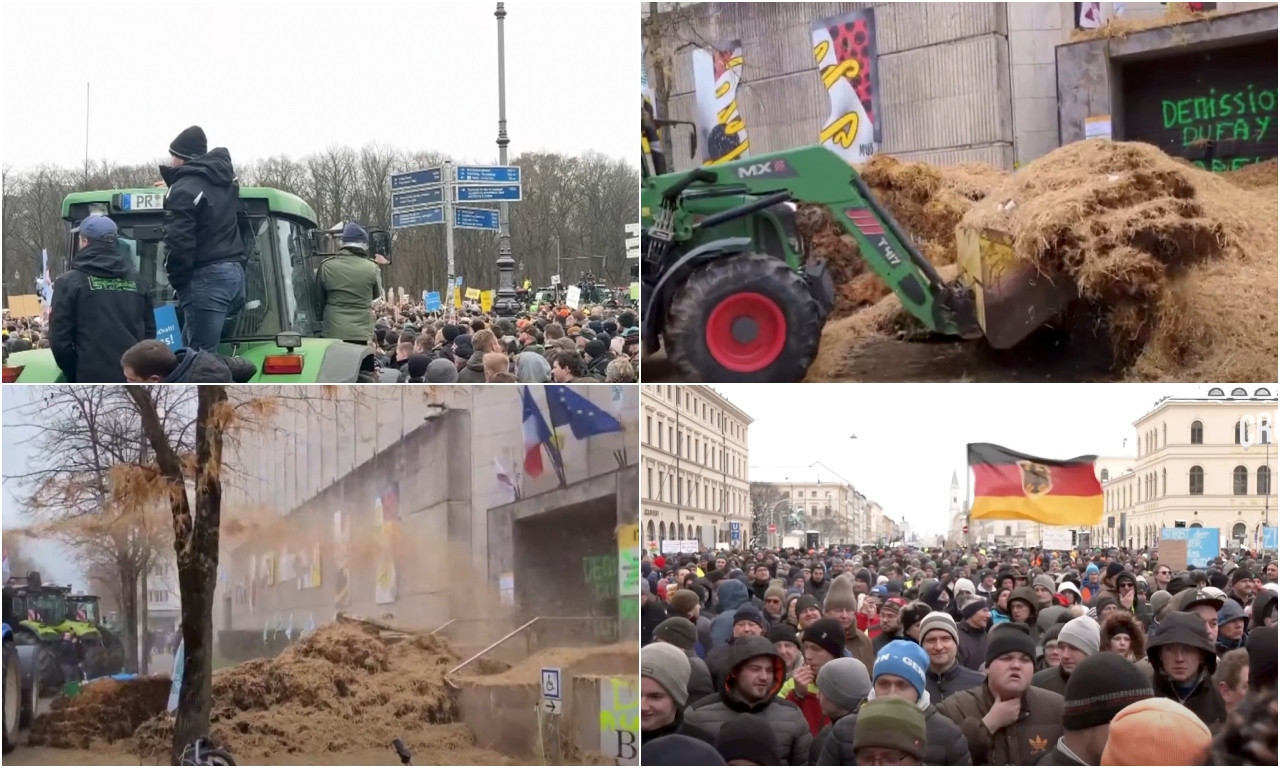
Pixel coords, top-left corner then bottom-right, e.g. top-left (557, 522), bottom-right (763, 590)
top-left (1147, 613), bottom-right (1226, 728)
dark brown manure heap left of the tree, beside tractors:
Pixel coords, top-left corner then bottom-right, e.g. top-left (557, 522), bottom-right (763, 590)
top-left (28, 676), bottom-right (170, 749)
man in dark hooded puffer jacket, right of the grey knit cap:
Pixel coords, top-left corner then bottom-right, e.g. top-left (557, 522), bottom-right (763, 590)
top-left (685, 637), bottom-right (813, 765)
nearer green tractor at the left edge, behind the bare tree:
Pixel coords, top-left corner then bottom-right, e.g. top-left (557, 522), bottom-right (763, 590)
top-left (4, 571), bottom-right (105, 695)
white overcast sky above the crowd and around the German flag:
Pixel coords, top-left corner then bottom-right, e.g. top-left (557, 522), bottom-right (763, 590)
top-left (714, 384), bottom-right (1252, 534)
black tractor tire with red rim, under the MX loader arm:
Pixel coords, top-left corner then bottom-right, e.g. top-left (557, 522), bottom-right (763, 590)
top-left (663, 253), bottom-right (823, 384)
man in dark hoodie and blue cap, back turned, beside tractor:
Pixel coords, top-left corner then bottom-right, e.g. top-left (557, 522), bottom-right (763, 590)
top-left (49, 216), bottom-right (156, 384)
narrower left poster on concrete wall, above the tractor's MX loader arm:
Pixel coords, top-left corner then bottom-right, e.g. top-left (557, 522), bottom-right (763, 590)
top-left (690, 40), bottom-right (749, 165)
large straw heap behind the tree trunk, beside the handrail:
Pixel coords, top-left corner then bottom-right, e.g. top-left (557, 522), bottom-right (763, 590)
top-left (136, 622), bottom-right (465, 759)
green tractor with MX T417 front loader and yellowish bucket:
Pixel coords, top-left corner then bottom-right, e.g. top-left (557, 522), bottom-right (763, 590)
top-left (640, 102), bottom-right (1078, 383)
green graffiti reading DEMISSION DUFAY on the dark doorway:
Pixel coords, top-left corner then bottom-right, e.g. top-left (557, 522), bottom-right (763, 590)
top-left (1161, 86), bottom-right (1276, 172)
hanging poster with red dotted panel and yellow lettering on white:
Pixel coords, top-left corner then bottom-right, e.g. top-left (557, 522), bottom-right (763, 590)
top-left (812, 8), bottom-right (881, 165)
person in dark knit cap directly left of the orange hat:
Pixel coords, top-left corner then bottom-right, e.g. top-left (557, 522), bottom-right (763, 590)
top-left (1039, 653), bottom-right (1156, 765)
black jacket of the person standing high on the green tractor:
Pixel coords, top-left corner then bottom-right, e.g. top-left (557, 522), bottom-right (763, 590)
top-left (160, 147), bottom-right (244, 294)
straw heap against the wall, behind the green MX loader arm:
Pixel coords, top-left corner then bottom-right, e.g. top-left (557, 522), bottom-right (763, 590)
top-left (796, 155), bottom-right (1005, 320)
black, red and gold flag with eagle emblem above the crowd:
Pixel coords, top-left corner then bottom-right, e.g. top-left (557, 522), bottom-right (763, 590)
top-left (969, 443), bottom-right (1102, 526)
